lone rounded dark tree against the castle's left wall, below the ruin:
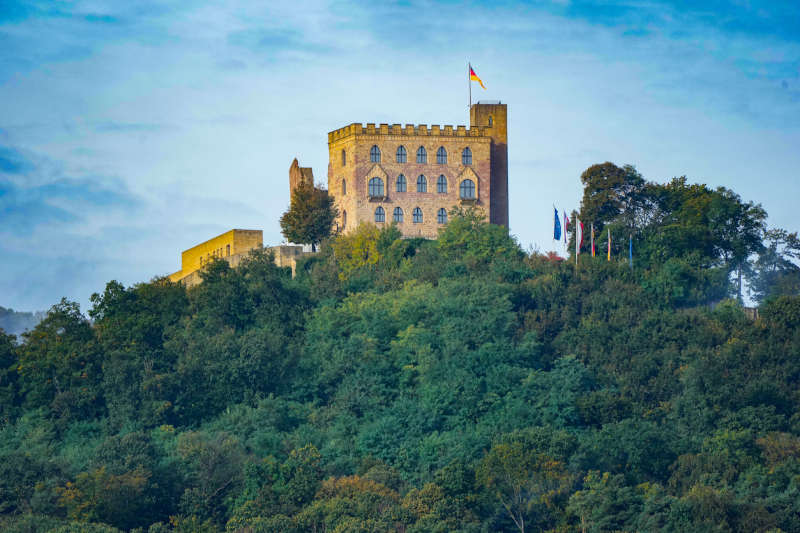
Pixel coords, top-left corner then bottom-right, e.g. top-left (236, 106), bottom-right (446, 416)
top-left (280, 182), bottom-right (339, 250)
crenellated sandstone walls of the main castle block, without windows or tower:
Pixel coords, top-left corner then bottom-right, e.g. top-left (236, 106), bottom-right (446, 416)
top-left (328, 124), bottom-right (492, 238)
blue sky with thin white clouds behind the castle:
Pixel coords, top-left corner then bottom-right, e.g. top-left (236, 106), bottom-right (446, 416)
top-left (0, 0), bottom-right (800, 311)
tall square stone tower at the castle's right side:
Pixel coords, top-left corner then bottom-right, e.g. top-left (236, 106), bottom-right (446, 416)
top-left (469, 101), bottom-right (508, 228)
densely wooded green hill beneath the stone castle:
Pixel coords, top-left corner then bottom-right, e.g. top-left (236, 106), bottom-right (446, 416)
top-left (0, 164), bottom-right (800, 533)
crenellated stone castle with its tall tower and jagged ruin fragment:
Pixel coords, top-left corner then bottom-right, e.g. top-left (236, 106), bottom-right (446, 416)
top-left (324, 102), bottom-right (508, 238)
